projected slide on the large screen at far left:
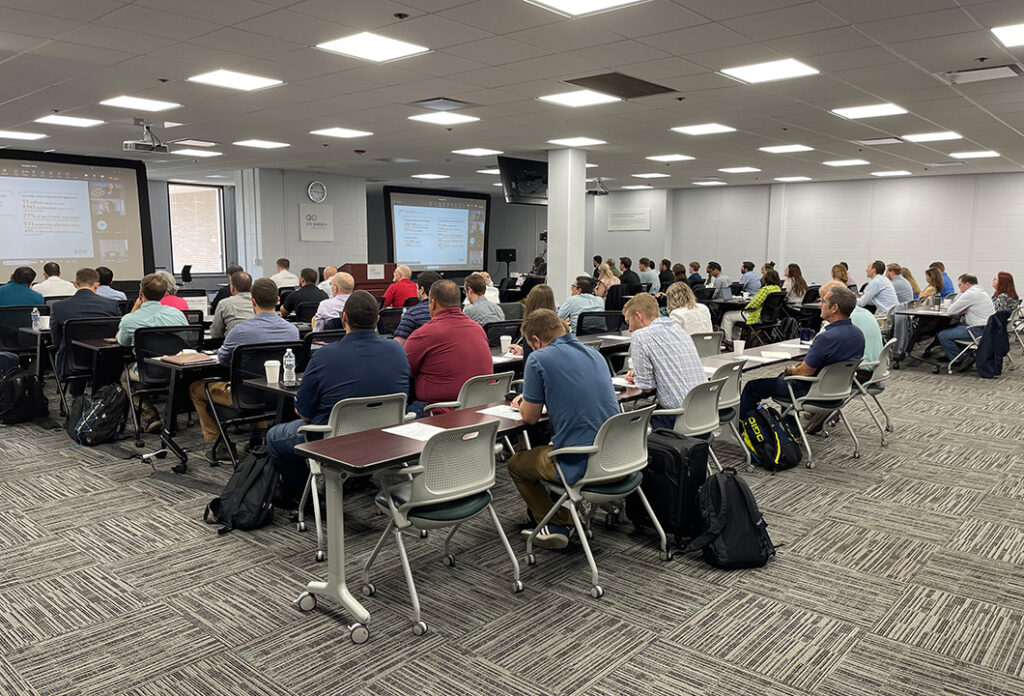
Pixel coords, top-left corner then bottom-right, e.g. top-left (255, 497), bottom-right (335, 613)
top-left (0, 151), bottom-right (147, 281)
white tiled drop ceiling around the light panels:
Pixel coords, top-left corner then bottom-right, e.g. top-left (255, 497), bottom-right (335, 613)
top-left (0, 0), bottom-right (1024, 190)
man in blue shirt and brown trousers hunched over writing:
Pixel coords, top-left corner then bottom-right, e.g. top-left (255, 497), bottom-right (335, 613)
top-left (509, 309), bottom-right (618, 549)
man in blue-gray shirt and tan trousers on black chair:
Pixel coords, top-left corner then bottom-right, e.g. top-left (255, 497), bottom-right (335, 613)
top-left (188, 278), bottom-right (299, 461)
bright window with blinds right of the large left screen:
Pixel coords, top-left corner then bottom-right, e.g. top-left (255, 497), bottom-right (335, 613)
top-left (167, 183), bottom-right (225, 273)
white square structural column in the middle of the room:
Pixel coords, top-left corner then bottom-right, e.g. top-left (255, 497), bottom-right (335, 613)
top-left (548, 149), bottom-right (587, 304)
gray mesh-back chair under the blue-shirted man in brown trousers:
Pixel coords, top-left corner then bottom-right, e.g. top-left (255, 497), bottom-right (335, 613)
top-left (526, 406), bottom-right (672, 599)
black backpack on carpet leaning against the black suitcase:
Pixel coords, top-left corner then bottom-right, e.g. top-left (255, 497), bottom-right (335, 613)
top-left (686, 467), bottom-right (775, 569)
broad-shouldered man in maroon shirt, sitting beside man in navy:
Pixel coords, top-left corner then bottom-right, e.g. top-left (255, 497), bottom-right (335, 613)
top-left (406, 280), bottom-right (495, 415)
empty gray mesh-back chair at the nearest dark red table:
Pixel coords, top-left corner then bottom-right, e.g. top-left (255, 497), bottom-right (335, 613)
top-left (362, 421), bottom-right (523, 636)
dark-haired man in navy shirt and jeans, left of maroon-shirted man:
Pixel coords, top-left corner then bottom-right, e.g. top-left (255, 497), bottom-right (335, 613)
top-left (266, 290), bottom-right (409, 503)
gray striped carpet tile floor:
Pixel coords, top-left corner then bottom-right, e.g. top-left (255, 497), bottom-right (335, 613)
top-left (0, 351), bottom-right (1024, 696)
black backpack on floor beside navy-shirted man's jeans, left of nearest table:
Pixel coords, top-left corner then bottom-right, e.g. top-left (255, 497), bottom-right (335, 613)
top-left (203, 451), bottom-right (278, 534)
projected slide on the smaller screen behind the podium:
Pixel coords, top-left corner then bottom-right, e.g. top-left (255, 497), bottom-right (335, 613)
top-left (385, 189), bottom-right (489, 271)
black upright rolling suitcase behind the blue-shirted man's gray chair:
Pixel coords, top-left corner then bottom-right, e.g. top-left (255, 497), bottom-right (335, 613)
top-left (626, 430), bottom-right (708, 546)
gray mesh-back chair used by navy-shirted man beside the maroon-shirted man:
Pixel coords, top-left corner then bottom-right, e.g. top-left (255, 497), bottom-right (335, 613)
top-left (296, 394), bottom-right (406, 561)
